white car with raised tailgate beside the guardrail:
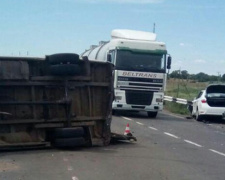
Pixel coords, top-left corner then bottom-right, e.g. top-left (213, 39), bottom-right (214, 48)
top-left (192, 85), bottom-right (225, 121)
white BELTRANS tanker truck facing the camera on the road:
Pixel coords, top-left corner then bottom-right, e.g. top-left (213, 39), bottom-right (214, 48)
top-left (81, 29), bottom-right (171, 118)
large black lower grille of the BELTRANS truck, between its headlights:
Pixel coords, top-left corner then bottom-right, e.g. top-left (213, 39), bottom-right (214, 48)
top-left (126, 90), bottom-right (153, 105)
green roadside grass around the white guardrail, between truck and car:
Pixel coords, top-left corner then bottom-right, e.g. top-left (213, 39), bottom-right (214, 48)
top-left (164, 78), bottom-right (208, 115)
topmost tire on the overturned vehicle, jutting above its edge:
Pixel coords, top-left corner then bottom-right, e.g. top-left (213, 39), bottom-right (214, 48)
top-left (47, 53), bottom-right (79, 65)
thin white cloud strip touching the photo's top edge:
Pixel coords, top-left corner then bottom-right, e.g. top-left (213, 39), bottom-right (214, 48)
top-left (78, 0), bottom-right (164, 4)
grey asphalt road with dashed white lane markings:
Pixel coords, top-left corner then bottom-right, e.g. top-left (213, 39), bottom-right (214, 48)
top-left (0, 112), bottom-right (225, 180)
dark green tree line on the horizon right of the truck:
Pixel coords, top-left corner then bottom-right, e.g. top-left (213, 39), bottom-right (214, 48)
top-left (168, 70), bottom-right (225, 82)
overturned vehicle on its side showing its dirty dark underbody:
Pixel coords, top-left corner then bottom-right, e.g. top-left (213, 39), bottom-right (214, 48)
top-left (0, 54), bottom-right (113, 150)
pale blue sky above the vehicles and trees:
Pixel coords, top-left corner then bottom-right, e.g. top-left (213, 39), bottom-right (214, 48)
top-left (0, 0), bottom-right (225, 75)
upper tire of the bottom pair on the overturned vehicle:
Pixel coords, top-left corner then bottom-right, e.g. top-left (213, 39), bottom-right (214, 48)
top-left (54, 127), bottom-right (85, 139)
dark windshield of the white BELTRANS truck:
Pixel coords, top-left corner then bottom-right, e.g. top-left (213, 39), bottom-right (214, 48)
top-left (115, 50), bottom-right (166, 73)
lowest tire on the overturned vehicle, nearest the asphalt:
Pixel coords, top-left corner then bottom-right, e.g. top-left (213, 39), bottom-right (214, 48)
top-left (54, 137), bottom-right (85, 147)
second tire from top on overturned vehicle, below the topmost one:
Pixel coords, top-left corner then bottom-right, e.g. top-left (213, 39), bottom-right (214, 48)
top-left (50, 64), bottom-right (81, 76)
